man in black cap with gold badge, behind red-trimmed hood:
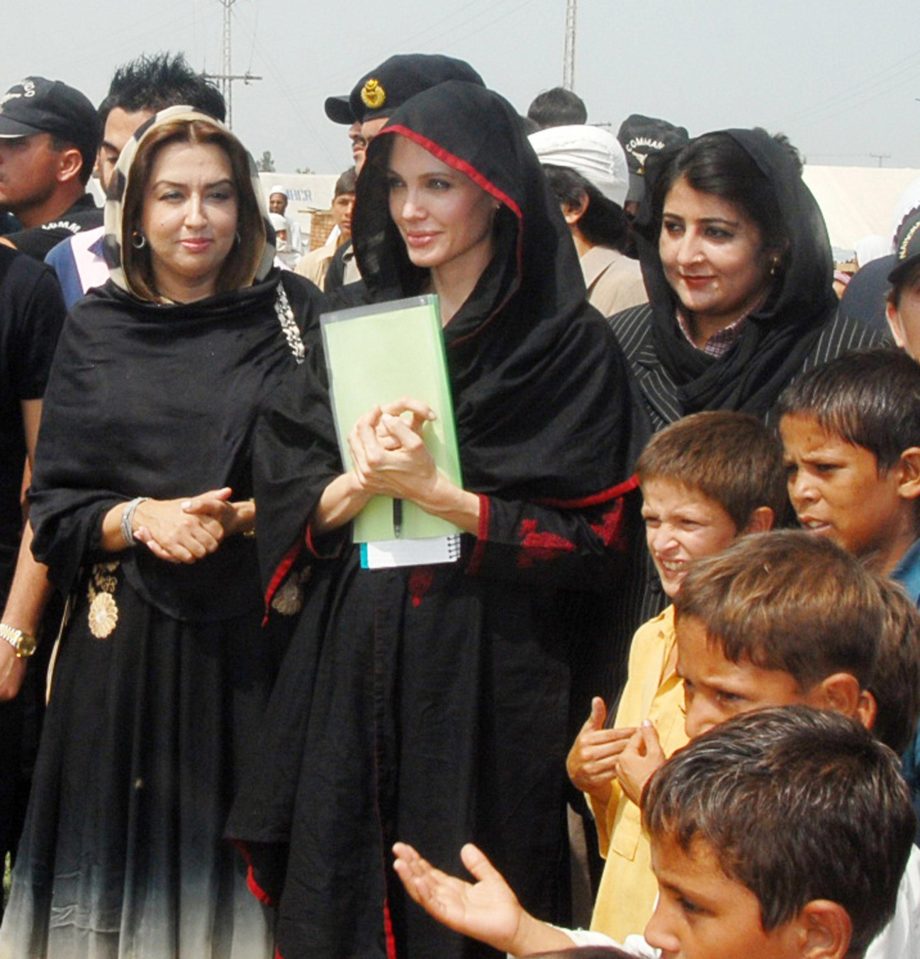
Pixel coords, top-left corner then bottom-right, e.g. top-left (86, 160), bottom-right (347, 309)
top-left (325, 53), bottom-right (485, 292)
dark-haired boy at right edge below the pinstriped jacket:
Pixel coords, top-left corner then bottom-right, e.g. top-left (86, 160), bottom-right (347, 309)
top-left (777, 346), bottom-right (920, 832)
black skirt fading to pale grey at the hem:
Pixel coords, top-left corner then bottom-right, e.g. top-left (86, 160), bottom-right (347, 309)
top-left (0, 563), bottom-right (282, 959)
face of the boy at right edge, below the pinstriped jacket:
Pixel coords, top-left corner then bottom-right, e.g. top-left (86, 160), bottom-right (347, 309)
top-left (779, 413), bottom-right (915, 572)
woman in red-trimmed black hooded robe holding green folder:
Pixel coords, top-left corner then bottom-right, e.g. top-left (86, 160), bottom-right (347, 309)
top-left (229, 82), bottom-right (633, 959)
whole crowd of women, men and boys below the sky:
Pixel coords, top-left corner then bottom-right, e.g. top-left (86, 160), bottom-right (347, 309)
top-left (0, 48), bottom-right (920, 959)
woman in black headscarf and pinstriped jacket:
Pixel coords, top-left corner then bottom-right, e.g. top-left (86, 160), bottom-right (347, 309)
top-left (596, 129), bottom-right (879, 672)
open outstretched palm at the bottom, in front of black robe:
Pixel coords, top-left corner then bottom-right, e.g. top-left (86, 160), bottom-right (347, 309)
top-left (393, 842), bottom-right (573, 956)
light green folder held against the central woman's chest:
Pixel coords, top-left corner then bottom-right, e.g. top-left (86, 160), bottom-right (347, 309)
top-left (320, 296), bottom-right (463, 543)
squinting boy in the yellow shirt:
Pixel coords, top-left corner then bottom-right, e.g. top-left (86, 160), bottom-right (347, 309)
top-left (567, 411), bottom-right (786, 940)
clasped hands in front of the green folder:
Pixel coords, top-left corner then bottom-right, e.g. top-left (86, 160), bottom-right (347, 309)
top-left (348, 398), bottom-right (438, 503)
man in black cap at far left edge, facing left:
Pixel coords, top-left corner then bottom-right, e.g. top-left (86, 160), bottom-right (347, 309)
top-left (0, 77), bottom-right (102, 259)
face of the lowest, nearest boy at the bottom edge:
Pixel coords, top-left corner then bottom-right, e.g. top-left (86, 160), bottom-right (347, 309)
top-left (645, 836), bottom-right (803, 959)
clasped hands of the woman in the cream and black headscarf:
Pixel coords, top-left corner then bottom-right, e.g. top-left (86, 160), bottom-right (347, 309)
top-left (134, 486), bottom-right (254, 563)
